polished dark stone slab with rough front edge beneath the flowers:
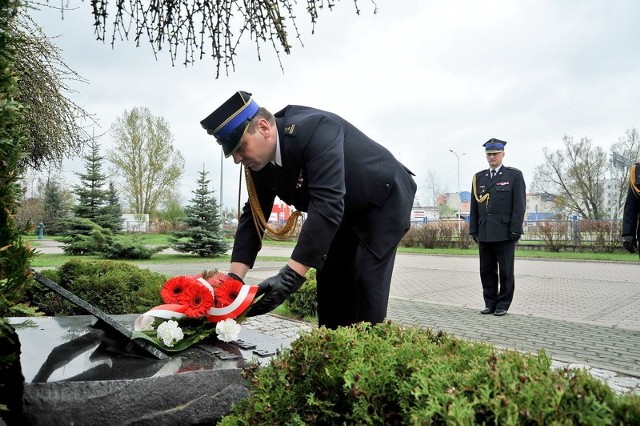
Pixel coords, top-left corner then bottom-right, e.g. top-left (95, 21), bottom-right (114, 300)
top-left (9, 315), bottom-right (285, 426)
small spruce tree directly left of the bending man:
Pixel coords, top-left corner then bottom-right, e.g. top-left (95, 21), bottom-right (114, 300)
top-left (171, 166), bottom-right (229, 257)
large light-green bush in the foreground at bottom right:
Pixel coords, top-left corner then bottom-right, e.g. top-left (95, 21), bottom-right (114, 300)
top-left (219, 323), bottom-right (640, 426)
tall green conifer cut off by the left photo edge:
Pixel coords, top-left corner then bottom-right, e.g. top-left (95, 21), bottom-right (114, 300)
top-left (0, 1), bottom-right (35, 425)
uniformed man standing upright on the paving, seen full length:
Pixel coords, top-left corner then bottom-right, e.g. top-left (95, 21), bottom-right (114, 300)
top-left (469, 139), bottom-right (527, 316)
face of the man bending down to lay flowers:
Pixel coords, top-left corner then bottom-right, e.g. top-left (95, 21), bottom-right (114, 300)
top-left (231, 119), bottom-right (275, 171)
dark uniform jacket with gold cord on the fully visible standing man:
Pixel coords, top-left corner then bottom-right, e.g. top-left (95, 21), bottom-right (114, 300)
top-left (469, 165), bottom-right (527, 242)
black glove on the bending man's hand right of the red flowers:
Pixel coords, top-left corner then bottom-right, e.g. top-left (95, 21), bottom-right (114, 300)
top-left (247, 265), bottom-right (306, 317)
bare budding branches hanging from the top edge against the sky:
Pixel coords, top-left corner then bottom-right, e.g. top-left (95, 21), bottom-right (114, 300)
top-left (38, 0), bottom-right (377, 78)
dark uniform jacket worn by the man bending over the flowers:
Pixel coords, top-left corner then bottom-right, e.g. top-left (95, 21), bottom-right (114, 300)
top-left (231, 105), bottom-right (416, 270)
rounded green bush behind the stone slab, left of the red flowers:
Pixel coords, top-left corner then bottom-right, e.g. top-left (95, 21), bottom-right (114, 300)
top-left (28, 260), bottom-right (167, 316)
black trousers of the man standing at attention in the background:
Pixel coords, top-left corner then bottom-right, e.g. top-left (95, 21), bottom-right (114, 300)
top-left (478, 240), bottom-right (516, 310)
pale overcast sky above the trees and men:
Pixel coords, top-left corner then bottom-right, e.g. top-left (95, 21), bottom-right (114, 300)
top-left (34, 0), bottom-right (640, 208)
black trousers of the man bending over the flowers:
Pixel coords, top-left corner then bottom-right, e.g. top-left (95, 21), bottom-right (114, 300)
top-left (316, 226), bottom-right (397, 329)
